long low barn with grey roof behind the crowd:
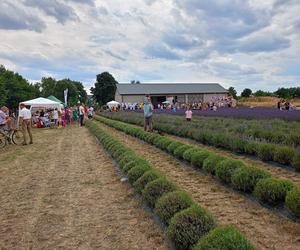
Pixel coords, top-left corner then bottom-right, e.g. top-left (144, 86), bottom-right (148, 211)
top-left (115, 83), bottom-right (228, 105)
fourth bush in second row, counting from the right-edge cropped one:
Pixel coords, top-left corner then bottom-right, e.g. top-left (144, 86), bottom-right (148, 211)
top-left (215, 159), bottom-right (245, 184)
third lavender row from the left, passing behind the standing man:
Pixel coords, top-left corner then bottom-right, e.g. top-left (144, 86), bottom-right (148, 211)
top-left (99, 113), bottom-right (300, 171)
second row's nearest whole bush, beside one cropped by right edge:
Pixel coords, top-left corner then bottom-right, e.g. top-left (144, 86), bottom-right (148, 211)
top-left (254, 178), bottom-right (294, 205)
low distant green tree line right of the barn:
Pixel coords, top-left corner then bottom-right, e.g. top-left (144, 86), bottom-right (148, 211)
top-left (228, 87), bottom-right (300, 99)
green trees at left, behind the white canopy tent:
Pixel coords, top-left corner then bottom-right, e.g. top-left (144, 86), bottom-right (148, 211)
top-left (0, 65), bottom-right (87, 109)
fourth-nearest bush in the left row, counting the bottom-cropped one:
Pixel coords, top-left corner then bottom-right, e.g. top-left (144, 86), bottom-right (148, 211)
top-left (143, 178), bottom-right (176, 208)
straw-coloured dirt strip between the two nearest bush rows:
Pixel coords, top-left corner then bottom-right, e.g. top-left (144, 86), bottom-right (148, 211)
top-left (99, 123), bottom-right (300, 250)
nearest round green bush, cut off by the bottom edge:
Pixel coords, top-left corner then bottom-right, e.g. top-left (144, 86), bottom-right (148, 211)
top-left (193, 226), bottom-right (255, 250)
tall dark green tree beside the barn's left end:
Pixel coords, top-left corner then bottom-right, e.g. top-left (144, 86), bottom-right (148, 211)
top-left (91, 72), bottom-right (118, 105)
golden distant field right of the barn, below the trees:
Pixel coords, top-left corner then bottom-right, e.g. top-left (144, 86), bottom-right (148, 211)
top-left (238, 96), bottom-right (300, 108)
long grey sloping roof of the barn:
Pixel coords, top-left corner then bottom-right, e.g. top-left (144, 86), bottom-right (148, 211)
top-left (117, 83), bottom-right (228, 95)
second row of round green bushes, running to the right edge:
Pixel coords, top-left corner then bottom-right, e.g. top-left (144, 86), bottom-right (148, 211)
top-left (96, 117), bottom-right (300, 218)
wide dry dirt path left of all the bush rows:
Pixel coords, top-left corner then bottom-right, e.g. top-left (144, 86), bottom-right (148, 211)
top-left (0, 127), bottom-right (167, 250)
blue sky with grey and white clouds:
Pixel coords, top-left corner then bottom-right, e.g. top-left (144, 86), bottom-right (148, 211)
top-left (0, 0), bottom-right (300, 94)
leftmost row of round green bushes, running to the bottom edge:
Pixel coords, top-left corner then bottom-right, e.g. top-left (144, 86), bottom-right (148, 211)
top-left (86, 121), bottom-right (255, 250)
